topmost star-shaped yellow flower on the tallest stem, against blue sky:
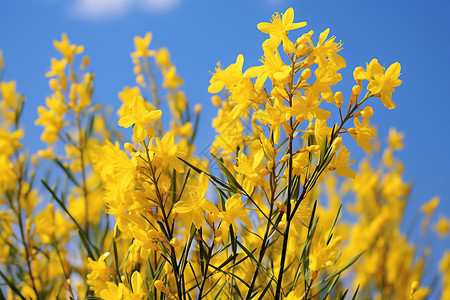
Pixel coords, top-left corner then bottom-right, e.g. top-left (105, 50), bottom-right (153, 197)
top-left (258, 7), bottom-right (306, 52)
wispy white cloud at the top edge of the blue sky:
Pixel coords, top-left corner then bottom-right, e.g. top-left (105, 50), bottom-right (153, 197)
top-left (70, 0), bottom-right (181, 20)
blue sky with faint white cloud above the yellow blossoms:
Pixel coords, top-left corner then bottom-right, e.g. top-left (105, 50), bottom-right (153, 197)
top-left (0, 0), bottom-right (450, 286)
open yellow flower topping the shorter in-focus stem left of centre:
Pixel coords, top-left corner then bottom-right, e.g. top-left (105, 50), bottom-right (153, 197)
top-left (119, 96), bottom-right (162, 142)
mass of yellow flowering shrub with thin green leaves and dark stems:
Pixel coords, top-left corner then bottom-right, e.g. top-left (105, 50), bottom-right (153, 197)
top-left (0, 8), bottom-right (450, 299)
